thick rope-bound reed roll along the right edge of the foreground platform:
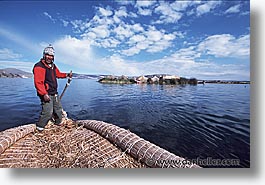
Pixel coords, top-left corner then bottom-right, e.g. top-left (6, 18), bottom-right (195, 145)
top-left (77, 120), bottom-right (199, 168)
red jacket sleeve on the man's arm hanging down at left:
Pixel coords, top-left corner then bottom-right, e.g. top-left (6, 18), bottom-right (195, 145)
top-left (33, 67), bottom-right (48, 95)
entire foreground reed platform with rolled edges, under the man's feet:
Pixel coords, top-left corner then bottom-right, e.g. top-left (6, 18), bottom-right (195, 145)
top-left (0, 119), bottom-right (200, 168)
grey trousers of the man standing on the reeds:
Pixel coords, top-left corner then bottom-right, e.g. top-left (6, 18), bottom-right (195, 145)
top-left (37, 94), bottom-right (62, 128)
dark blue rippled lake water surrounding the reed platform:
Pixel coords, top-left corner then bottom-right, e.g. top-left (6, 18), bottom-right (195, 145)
top-left (0, 78), bottom-right (250, 167)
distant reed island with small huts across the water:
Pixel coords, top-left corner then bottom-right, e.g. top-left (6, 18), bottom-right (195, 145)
top-left (98, 75), bottom-right (198, 85)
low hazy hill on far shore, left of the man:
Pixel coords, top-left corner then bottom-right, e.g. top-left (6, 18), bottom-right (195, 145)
top-left (0, 68), bottom-right (33, 78)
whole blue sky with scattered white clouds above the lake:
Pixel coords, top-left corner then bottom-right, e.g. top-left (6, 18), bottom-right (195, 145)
top-left (0, 0), bottom-right (250, 80)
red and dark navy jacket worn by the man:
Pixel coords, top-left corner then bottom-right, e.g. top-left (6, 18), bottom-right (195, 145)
top-left (33, 59), bottom-right (67, 97)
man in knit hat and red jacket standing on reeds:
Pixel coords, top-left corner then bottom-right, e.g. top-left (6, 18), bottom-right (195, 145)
top-left (33, 45), bottom-right (72, 131)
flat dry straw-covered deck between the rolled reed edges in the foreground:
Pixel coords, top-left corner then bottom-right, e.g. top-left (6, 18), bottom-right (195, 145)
top-left (0, 120), bottom-right (146, 168)
